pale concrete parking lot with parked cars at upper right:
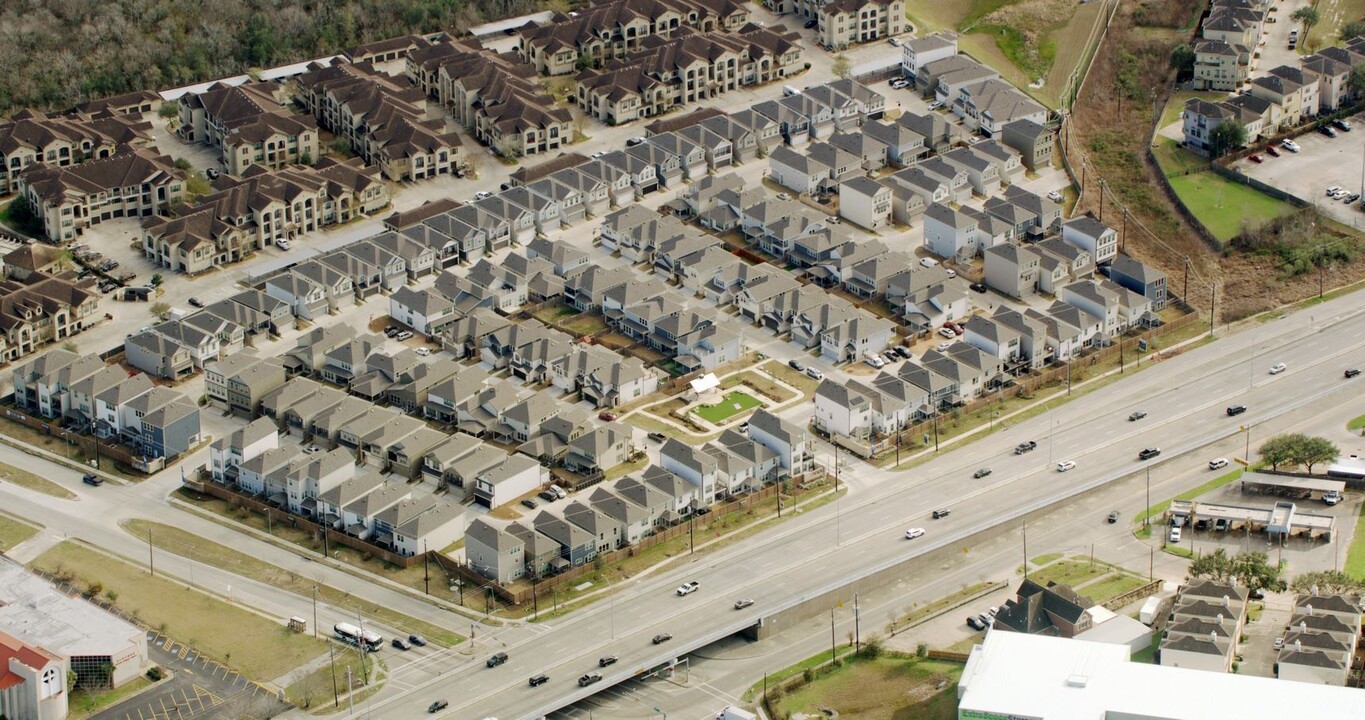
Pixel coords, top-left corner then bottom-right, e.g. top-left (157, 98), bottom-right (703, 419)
top-left (1233, 113), bottom-right (1365, 230)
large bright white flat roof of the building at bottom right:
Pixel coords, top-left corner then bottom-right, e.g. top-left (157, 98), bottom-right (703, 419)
top-left (957, 633), bottom-right (1365, 720)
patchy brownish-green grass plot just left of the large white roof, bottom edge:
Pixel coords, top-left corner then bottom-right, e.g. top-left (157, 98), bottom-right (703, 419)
top-left (770, 654), bottom-right (962, 720)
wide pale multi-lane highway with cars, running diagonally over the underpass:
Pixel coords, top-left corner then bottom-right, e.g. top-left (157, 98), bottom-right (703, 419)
top-left (352, 291), bottom-right (1365, 717)
